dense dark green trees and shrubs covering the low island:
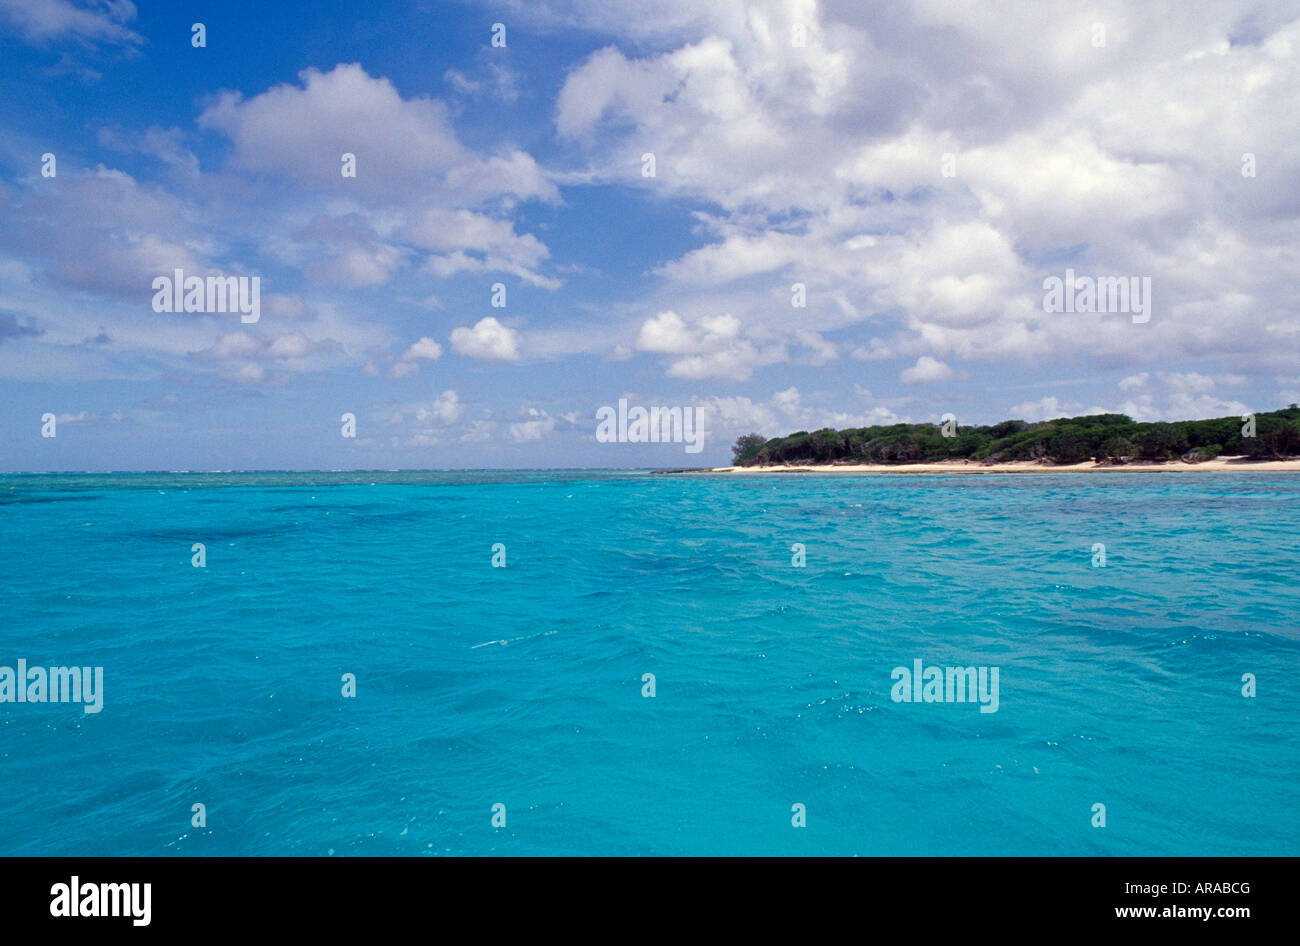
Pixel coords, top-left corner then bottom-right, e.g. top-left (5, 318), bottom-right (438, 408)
top-left (732, 404), bottom-right (1300, 467)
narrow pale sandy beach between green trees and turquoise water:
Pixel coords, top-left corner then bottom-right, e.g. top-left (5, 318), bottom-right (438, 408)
top-left (654, 457), bottom-right (1300, 476)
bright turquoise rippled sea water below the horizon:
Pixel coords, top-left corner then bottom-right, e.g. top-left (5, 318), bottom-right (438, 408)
top-left (0, 470), bottom-right (1300, 856)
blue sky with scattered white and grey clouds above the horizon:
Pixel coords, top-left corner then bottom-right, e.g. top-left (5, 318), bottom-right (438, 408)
top-left (0, 0), bottom-right (1300, 470)
